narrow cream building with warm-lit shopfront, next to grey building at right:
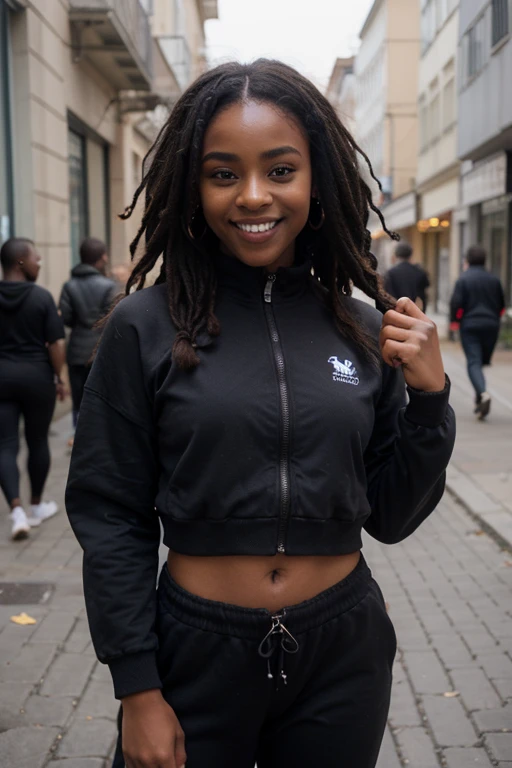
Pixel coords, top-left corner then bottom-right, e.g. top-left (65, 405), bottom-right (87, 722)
top-left (416, 0), bottom-right (460, 315)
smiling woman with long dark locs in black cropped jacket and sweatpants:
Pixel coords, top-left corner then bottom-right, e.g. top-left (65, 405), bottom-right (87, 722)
top-left (66, 59), bottom-right (454, 768)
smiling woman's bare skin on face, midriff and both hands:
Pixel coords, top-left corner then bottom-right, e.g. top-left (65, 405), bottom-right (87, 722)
top-left (123, 101), bottom-right (445, 768)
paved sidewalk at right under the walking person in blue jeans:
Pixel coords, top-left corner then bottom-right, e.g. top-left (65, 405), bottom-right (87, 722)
top-left (443, 343), bottom-right (512, 549)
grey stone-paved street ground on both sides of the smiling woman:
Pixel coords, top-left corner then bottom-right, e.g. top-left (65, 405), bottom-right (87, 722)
top-left (0, 344), bottom-right (512, 768)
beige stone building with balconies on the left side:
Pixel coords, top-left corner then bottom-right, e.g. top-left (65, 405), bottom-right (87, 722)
top-left (0, 0), bottom-right (217, 296)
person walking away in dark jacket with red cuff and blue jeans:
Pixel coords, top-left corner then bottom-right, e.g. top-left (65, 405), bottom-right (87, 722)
top-left (450, 245), bottom-right (505, 421)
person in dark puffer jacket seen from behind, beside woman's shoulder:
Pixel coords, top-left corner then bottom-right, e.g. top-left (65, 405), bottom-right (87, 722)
top-left (59, 237), bottom-right (119, 446)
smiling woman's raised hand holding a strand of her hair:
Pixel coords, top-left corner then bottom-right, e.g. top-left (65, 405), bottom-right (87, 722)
top-left (380, 298), bottom-right (445, 392)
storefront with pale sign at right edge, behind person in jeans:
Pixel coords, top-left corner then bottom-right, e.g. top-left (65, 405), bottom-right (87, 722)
top-left (461, 152), bottom-right (512, 302)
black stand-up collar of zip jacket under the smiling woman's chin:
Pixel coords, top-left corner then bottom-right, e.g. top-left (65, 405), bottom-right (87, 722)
top-left (214, 251), bottom-right (311, 302)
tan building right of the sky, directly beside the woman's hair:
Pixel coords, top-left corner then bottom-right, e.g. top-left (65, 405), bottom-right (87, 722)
top-left (355, 0), bottom-right (420, 270)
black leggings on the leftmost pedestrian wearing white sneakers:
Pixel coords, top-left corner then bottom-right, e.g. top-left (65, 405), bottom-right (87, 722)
top-left (0, 360), bottom-right (56, 505)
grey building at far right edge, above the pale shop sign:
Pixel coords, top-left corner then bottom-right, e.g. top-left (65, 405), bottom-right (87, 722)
top-left (458, 0), bottom-right (512, 302)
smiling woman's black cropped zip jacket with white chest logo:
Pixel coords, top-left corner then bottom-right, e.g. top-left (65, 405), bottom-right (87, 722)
top-left (66, 256), bottom-right (455, 698)
